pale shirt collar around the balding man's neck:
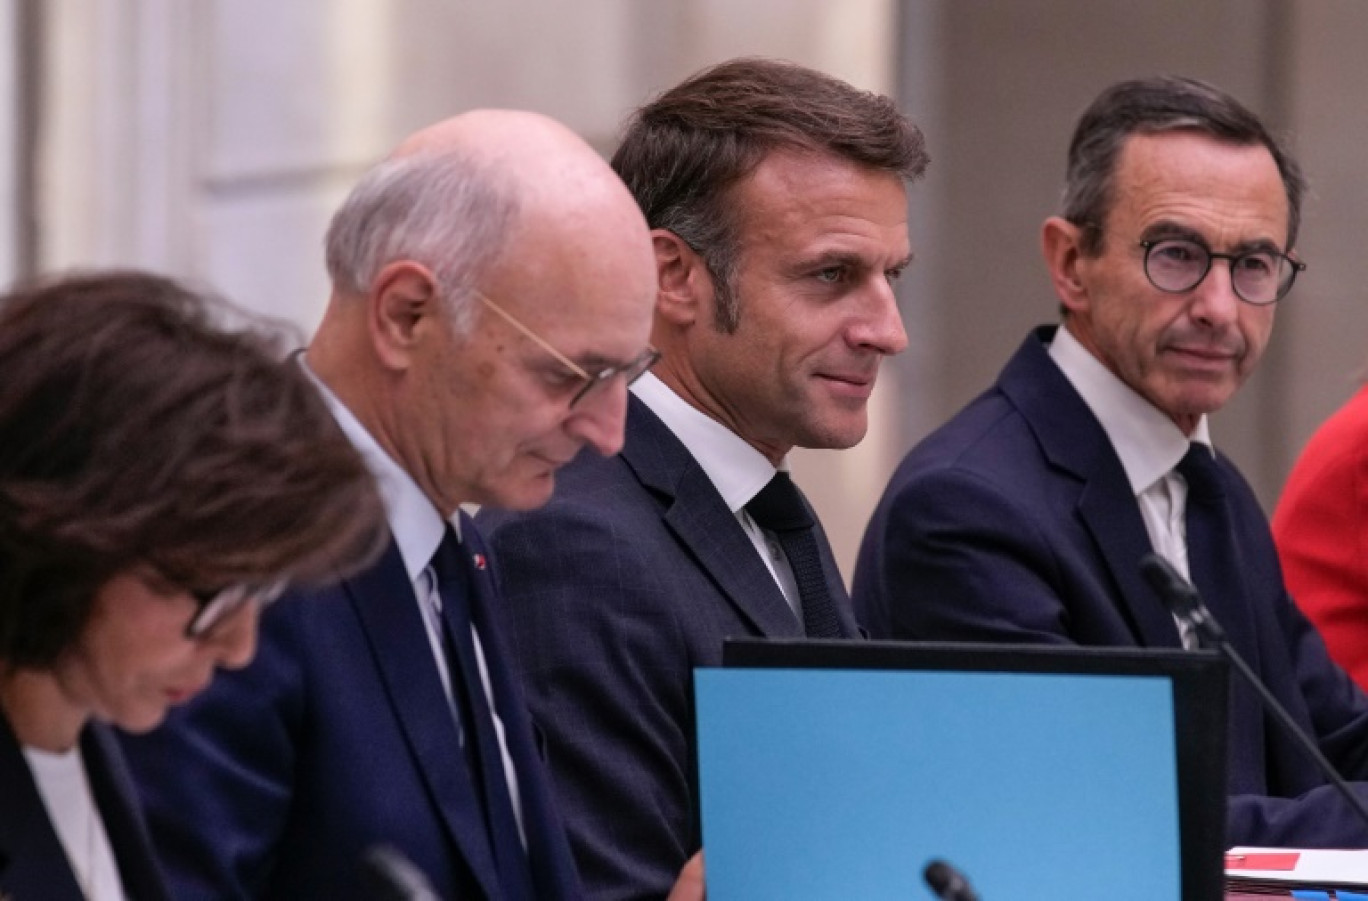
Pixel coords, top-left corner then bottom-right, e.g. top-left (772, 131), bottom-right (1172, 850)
top-left (300, 354), bottom-right (461, 582)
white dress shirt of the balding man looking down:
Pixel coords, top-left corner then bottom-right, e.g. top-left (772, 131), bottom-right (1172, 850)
top-left (300, 357), bottom-right (527, 846)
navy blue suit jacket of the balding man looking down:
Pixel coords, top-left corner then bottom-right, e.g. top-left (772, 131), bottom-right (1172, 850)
top-left (119, 518), bottom-right (581, 901)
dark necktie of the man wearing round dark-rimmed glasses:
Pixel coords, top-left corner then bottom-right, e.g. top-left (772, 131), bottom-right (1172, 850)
top-left (1178, 442), bottom-right (1239, 642)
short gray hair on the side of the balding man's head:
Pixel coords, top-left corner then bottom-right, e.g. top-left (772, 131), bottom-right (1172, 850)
top-left (326, 149), bottom-right (518, 334)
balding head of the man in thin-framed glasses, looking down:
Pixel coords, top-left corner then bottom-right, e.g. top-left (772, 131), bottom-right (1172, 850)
top-left (308, 109), bottom-right (655, 514)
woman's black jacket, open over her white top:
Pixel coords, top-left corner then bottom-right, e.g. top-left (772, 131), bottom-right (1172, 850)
top-left (0, 715), bottom-right (168, 901)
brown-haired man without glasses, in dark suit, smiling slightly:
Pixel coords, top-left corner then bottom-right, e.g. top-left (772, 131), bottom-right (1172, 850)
top-left (480, 60), bottom-right (926, 898)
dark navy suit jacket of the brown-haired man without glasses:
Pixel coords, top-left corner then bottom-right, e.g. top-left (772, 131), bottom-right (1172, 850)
top-left (479, 396), bottom-right (856, 898)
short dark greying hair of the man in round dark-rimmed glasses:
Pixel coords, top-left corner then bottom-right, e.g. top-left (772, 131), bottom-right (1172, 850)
top-left (1064, 75), bottom-right (1306, 256)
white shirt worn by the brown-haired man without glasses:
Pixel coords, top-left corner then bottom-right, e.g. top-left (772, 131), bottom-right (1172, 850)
top-left (632, 372), bottom-right (803, 622)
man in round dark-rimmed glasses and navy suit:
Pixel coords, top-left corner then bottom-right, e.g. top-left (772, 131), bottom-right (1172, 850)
top-left (854, 78), bottom-right (1368, 846)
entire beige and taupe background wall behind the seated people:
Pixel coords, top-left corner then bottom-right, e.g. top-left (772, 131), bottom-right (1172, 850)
top-left (10, 0), bottom-right (1368, 585)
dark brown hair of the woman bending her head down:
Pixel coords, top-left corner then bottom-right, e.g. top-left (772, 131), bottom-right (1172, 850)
top-left (0, 272), bottom-right (384, 669)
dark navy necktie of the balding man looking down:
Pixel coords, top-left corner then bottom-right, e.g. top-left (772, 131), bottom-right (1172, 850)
top-left (432, 526), bottom-right (534, 901)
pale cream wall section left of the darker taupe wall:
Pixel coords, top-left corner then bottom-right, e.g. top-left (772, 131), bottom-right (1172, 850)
top-left (26, 0), bottom-right (900, 576)
